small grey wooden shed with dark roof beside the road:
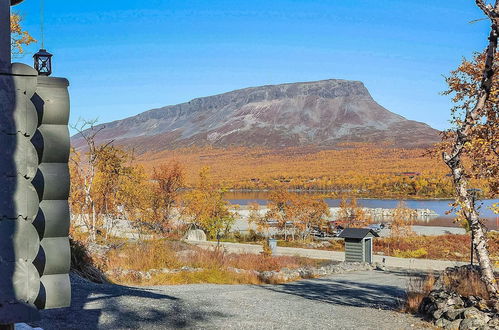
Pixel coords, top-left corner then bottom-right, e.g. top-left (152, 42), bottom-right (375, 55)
top-left (338, 228), bottom-right (379, 263)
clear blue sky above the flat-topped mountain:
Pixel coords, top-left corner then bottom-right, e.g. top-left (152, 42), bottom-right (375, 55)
top-left (14, 0), bottom-right (489, 129)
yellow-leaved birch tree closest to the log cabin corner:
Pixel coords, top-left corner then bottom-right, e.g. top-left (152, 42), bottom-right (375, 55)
top-left (69, 120), bottom-right (146, 241)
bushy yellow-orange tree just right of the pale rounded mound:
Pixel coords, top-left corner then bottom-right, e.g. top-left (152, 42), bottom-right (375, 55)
top-left (184, 167), bottom-right (236, 247)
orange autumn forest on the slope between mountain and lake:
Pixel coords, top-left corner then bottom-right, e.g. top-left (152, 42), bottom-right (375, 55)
top-left (138, 143), bottom-right (488, 198)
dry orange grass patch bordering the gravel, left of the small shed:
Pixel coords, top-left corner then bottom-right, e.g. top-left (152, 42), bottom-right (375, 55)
top-left (104, 240), bottom-right (323, 285)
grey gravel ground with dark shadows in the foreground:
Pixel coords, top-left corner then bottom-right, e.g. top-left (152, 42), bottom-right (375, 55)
top-left (36, 271), bottom-right (427, 330)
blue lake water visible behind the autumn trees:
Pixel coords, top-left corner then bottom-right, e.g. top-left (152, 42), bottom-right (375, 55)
top-left (225, 191), bottom-right (499, 230)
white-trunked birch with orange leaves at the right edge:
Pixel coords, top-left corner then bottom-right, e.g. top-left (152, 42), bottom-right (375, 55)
top-left (442, 0), bottom-right (499, 299)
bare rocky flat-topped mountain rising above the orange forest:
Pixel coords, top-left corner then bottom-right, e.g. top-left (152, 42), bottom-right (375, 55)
top-left (73, 79), bottom-right (439, 153)
